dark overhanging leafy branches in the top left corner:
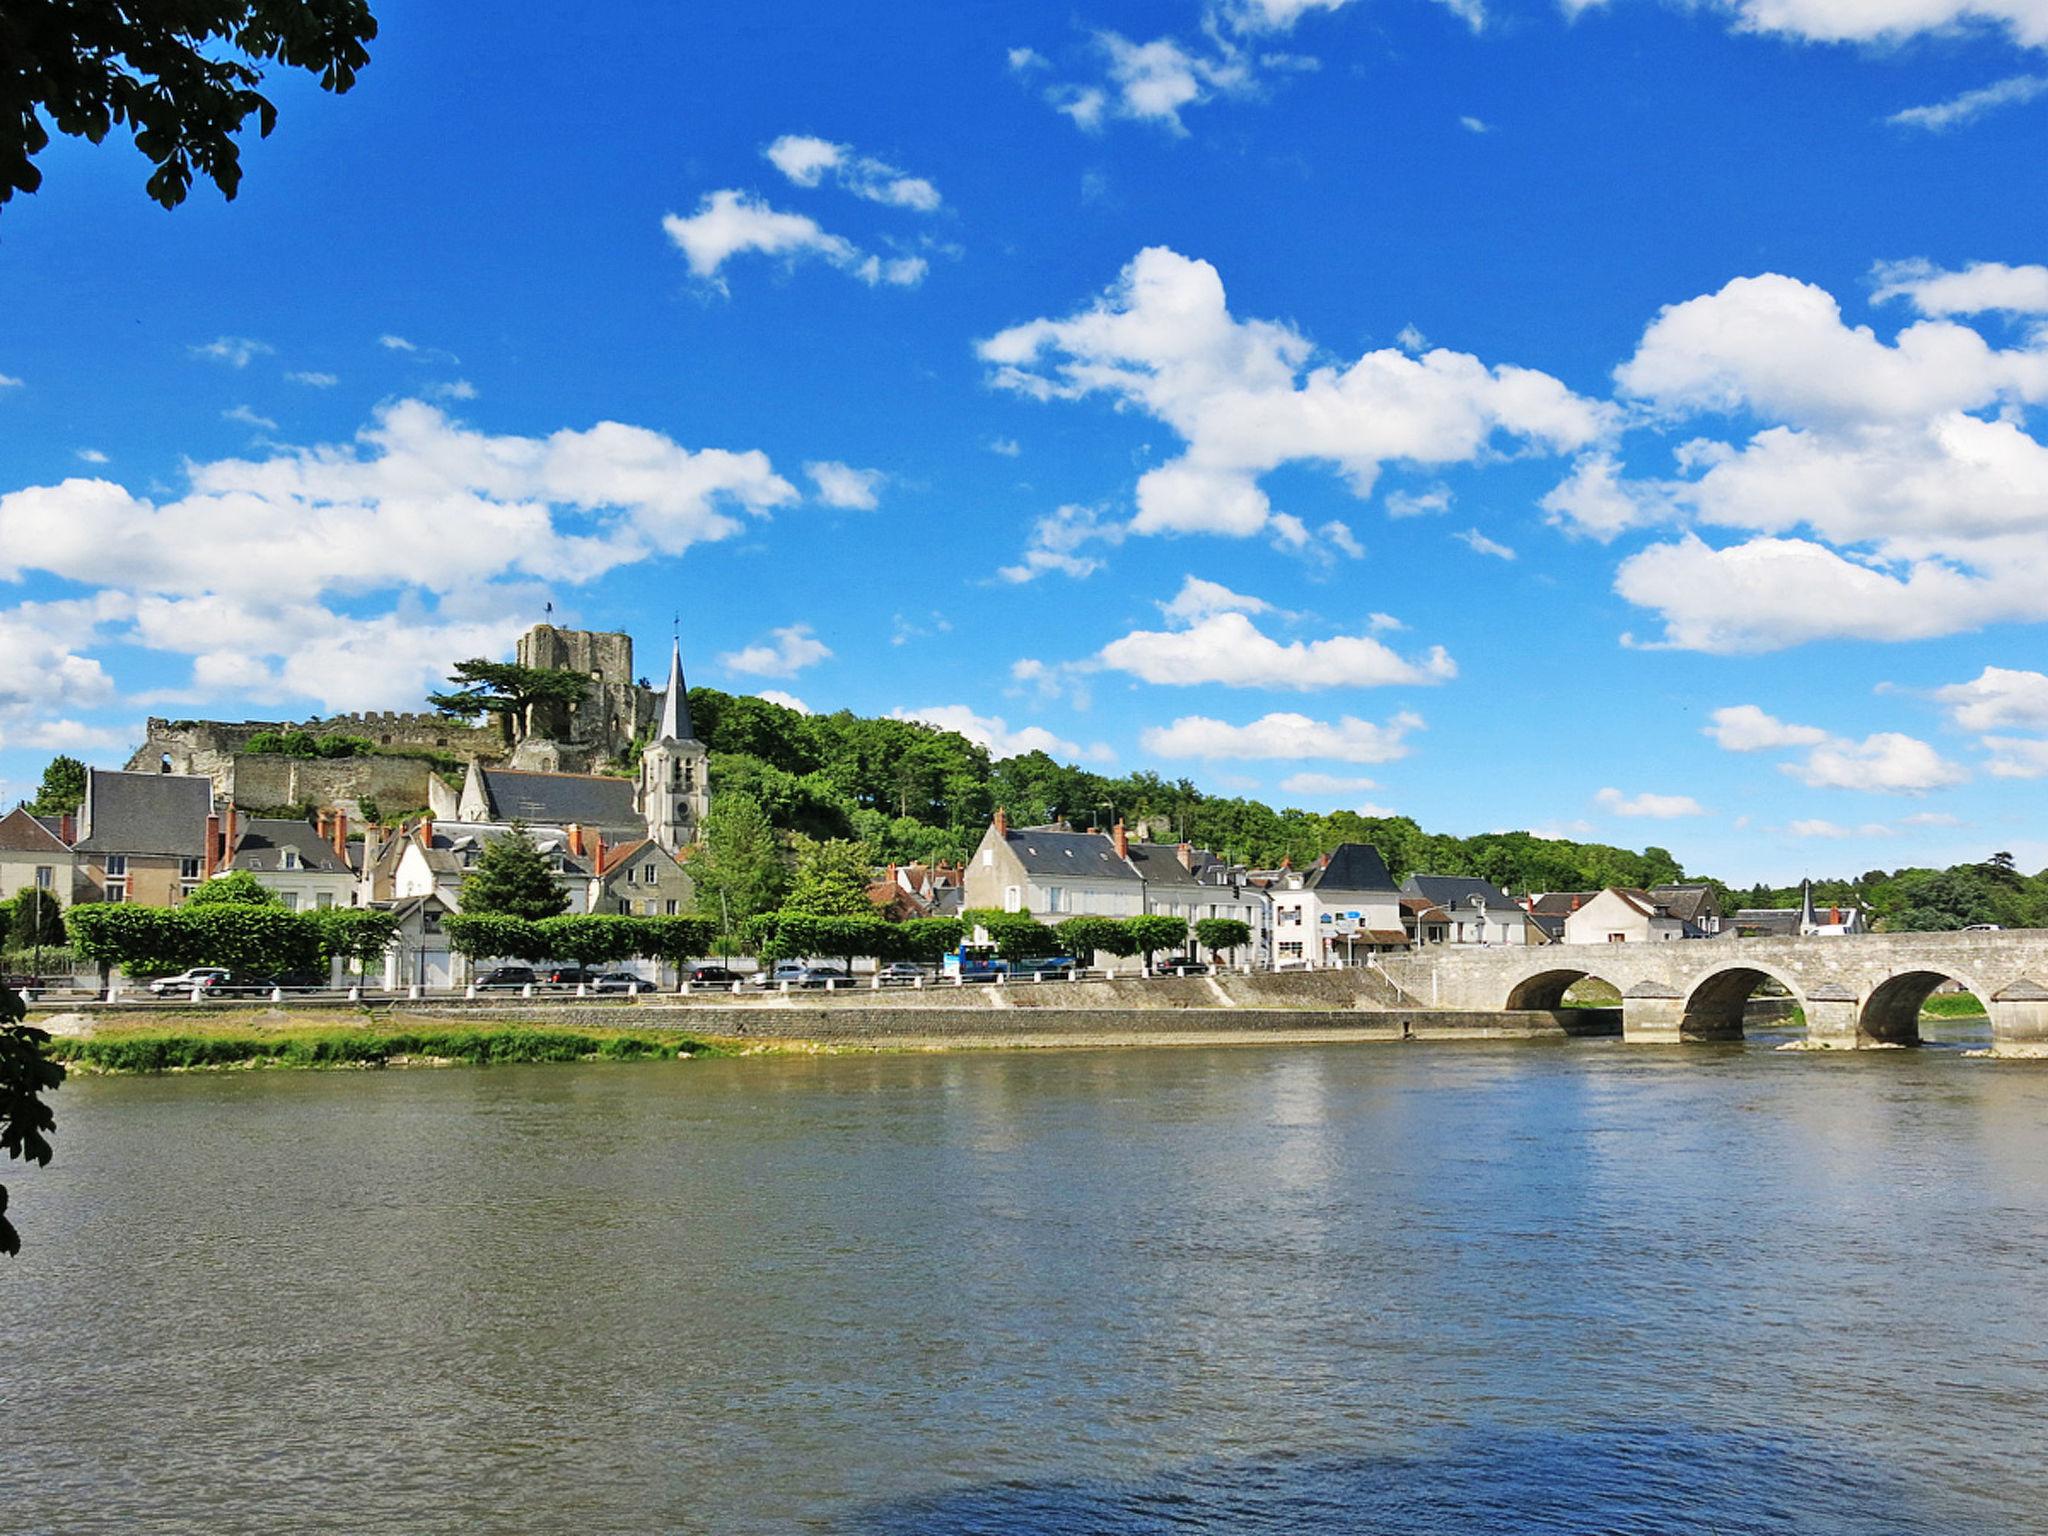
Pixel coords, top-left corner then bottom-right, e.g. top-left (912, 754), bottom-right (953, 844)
top-left (0, 0), bottom-right (377, 209)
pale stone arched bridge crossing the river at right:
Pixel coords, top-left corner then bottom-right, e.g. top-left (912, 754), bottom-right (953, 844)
top-left (1378, 930), bottom-right (2048, 1055)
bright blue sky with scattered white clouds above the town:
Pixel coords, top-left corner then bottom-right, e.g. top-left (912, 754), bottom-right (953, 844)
top-left (0, 0), bottom-right (2048, 885)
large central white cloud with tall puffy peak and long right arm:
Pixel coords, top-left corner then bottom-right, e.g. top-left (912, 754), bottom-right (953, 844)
top-left (979, 246), bottom-right (1612, 539)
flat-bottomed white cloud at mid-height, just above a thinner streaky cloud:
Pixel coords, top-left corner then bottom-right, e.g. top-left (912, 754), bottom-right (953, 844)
top-left (1096, 612), bottom-right (1458, 692)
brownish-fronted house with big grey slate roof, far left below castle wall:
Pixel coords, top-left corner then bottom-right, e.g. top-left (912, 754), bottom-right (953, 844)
top-left (74, 768), bottom-right (213, 907)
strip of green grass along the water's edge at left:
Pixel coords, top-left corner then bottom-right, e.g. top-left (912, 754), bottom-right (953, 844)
top-left (47, 1018), bottom-right (737, 1073)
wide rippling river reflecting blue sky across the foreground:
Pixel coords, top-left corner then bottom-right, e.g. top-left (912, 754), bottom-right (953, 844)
top-left (0, 1040), bottom-right (2048, 1536)
